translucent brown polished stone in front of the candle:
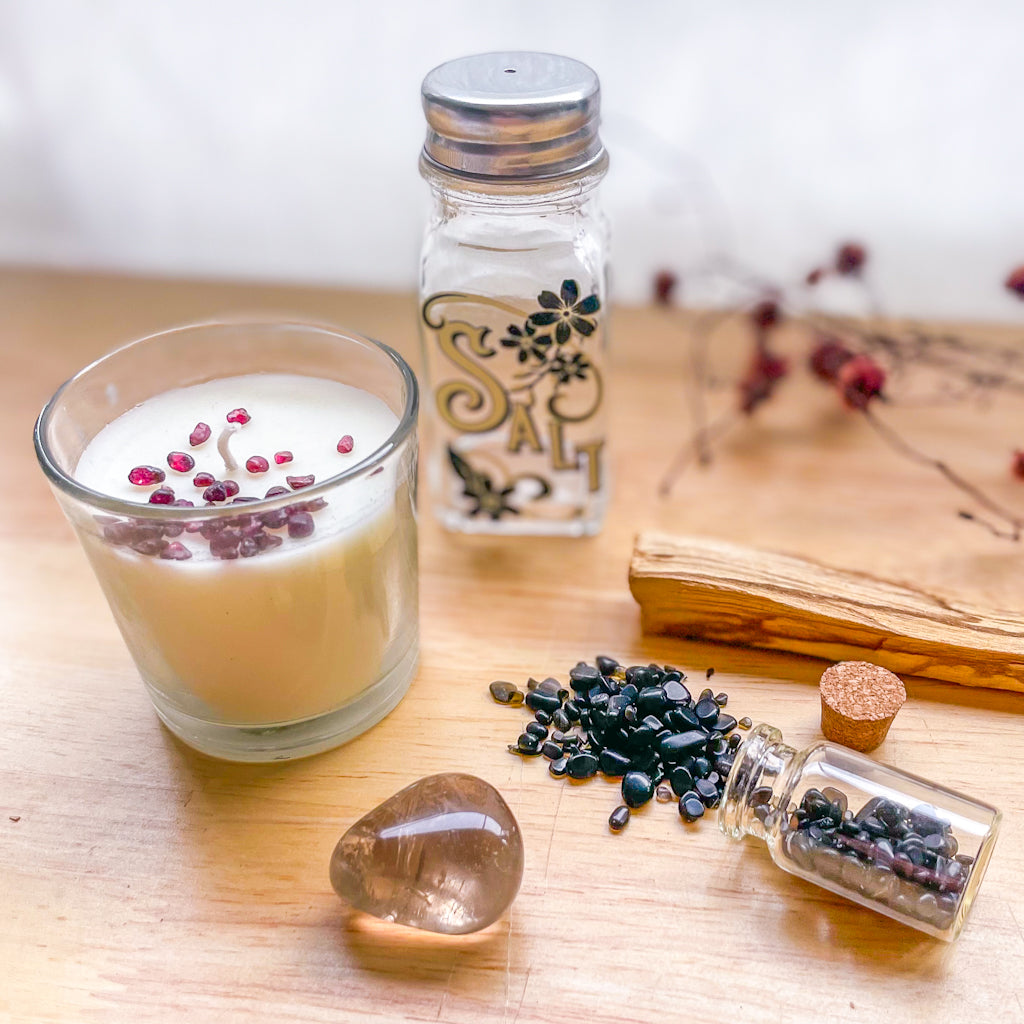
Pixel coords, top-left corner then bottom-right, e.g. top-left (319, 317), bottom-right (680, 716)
top-left (331, 772), bottom-right (523, 935)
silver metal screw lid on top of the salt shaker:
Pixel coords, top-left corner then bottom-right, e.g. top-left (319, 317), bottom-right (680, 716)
top-left (423, 52), bottom-right (605, 181)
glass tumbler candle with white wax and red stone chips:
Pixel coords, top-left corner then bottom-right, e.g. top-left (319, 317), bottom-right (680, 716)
top-left (35, 324), bottom-right (419, 761)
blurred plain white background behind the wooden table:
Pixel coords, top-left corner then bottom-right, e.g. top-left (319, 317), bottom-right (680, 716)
top-left (0, 0), bottom-right (1024, 318)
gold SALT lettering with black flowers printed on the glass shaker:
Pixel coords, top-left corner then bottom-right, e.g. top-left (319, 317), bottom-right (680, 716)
top-left (423, 279), bottom-right (604, 520)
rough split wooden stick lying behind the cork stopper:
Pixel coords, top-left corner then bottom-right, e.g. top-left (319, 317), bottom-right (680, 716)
top-left (630, 532), bottom-right (1024, 691)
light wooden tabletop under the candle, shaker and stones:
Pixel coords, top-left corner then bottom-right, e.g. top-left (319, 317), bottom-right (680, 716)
top-left (0, 269), bottom-right (1024, 1024)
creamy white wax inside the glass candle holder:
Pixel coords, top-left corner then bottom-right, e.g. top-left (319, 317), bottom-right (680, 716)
top-left (74, 374), bottom-right (416, 725)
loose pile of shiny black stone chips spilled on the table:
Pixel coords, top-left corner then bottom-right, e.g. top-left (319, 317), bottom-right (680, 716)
top-left (489, 655), bottom-right (751, 831)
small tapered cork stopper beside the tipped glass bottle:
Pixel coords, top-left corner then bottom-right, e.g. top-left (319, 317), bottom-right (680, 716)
top-left (818, 662), bottom-right (906, 753)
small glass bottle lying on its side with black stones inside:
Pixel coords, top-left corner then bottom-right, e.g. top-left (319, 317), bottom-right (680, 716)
top-left (719, 725), bottom-right (1000, 941)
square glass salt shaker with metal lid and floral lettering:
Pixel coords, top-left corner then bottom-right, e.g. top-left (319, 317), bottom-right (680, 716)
top-left (420, 52), bottom-right (608, 536)
